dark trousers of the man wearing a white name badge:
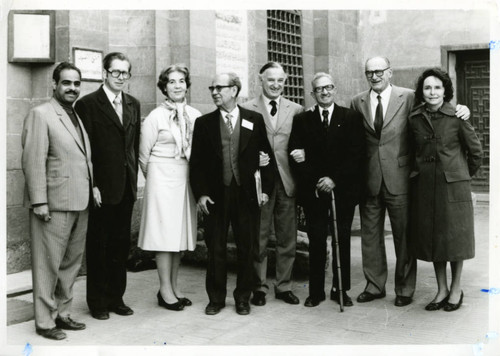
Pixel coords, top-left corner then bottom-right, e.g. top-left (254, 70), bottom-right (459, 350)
top-left (205, 179), bottom-right (260, 304)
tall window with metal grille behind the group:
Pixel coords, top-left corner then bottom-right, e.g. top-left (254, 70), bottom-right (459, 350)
top-left (267, 10), bottom-right (304, 105)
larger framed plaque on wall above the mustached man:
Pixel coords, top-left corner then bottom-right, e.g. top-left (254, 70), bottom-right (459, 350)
top-left (9, 10), bottom-right (56, 63)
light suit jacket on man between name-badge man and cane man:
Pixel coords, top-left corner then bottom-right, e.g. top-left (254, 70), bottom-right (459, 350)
top-left (241, 95), bottom-right (303, 197)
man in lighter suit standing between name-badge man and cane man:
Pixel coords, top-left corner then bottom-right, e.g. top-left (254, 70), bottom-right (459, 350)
top-left (242, 62), bottom-right (303, 306)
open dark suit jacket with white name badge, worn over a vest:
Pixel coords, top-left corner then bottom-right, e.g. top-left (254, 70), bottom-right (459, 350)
top-left (189, 107), bottom-right (274, 208)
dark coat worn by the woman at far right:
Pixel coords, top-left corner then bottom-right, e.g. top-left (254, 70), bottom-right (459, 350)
top-left (409, 103), bottom-right (483, 262)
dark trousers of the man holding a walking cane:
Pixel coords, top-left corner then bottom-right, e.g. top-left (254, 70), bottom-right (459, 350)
top-left (304, 194), bottom-right (356, 299)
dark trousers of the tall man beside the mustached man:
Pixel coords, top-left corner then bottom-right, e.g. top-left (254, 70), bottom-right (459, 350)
top-left (86, 185), bottom-right (134, 310)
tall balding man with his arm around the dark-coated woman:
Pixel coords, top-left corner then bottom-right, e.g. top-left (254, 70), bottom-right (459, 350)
top-left (351, 57), bottom-right (470, 307)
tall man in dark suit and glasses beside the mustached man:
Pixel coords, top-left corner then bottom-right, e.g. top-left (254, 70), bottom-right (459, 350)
top-left (75, 52), bottom-right (141, 320)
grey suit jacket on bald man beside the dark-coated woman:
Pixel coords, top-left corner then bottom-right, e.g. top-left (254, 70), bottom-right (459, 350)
top-left (351, 85), bottom-right (415, 196)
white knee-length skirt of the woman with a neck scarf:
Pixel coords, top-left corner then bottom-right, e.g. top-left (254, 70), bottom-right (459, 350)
top-left (138, 157), bottom-right (197, 252)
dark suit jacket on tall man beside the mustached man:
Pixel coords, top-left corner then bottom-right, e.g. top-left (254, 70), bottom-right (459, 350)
top-left (75, 86), bottom-right (141, 204)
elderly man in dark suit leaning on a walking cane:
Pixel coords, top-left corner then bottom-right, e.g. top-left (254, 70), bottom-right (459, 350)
top-left (288, 73), bottom-right (365, 307)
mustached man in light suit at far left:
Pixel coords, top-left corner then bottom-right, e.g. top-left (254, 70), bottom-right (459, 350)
top-left (22, 62), bottom-right (92, 340)
